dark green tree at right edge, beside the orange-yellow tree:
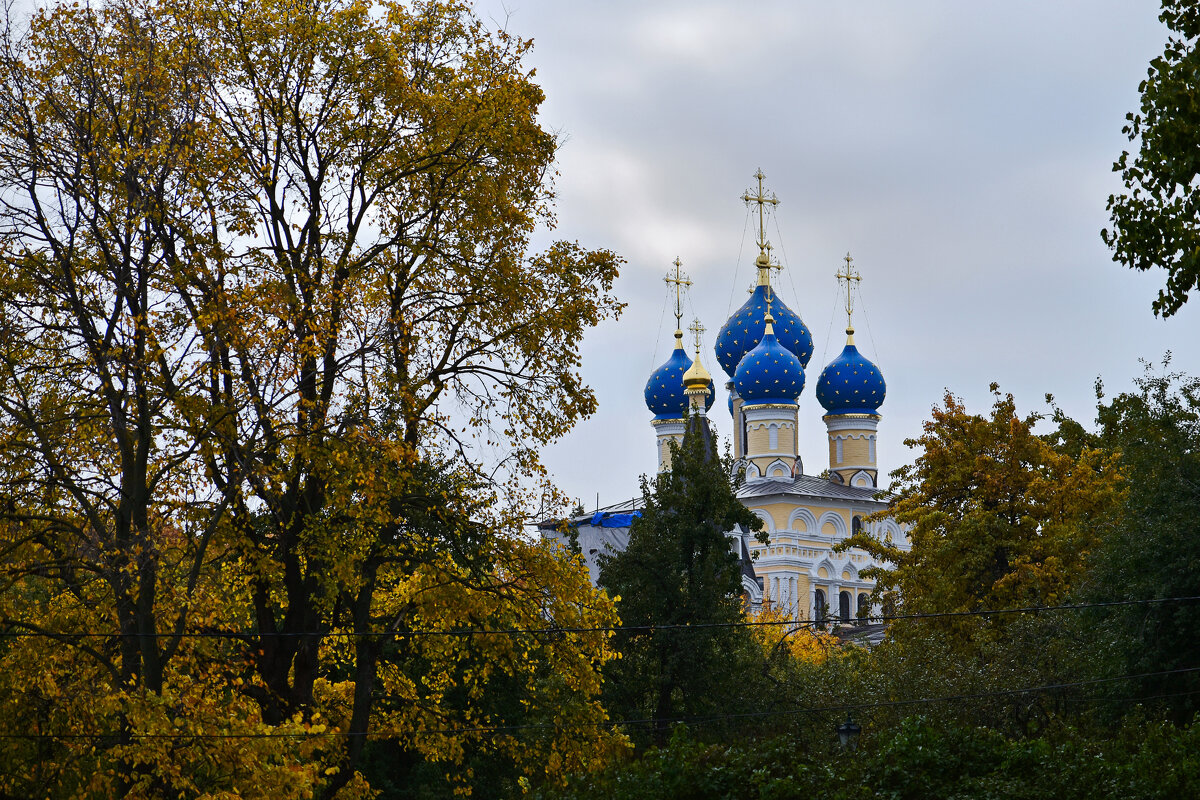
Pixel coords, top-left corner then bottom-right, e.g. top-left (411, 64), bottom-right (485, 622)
top-left (1082, 356), bottom-right (1200, 720)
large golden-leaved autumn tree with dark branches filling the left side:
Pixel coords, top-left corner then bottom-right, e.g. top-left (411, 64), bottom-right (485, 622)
top-left (0, 0), bottom-right (619, 795)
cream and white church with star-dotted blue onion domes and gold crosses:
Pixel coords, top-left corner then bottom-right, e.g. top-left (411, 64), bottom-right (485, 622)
top-left (539, 170), bottom-right (908, 621)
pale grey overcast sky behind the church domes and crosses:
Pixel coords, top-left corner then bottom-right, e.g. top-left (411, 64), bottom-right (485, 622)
top-left (478, 0), bottom-right (1200, 507)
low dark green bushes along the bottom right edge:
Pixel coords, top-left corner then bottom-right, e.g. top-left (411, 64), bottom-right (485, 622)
top-left (541, 716), bottom-right (1200, 800)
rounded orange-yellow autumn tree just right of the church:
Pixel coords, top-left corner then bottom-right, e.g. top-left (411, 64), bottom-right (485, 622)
top-left (846, 385), bottom-right (1123, 626)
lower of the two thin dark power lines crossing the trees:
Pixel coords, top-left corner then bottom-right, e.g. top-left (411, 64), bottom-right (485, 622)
top-left (0, 667), bottom-right (1200, 740)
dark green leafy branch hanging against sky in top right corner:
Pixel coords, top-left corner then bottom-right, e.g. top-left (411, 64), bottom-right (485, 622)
top-left (1102, 0), bottom-right (1200, 317)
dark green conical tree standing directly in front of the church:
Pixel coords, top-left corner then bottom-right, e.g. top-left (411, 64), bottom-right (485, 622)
top-left (600, 417), bottom-right (762, 742)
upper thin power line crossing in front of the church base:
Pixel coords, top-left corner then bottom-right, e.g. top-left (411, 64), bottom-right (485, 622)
top-left (0, 595), bottom-right (1200, 639)
